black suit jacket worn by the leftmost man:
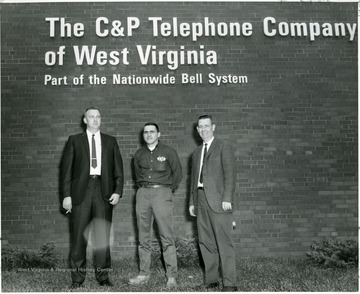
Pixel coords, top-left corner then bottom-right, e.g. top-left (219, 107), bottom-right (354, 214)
top-left (61, 132), bottom-right (124, 205)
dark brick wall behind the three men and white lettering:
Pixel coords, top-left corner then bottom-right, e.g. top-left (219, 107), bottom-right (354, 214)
top-left (1, 2), bottom-right (358, 258)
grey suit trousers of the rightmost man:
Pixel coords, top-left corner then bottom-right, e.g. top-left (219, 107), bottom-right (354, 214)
top-left (197, 190), bottom-right (236, 286)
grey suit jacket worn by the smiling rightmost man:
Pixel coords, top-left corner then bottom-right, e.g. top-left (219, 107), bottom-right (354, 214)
top-left (190, 138), bottom-right (235, 213)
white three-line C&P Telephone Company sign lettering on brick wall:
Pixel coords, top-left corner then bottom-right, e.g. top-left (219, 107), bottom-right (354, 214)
top-left (44, 16), bottom-right (357, 86)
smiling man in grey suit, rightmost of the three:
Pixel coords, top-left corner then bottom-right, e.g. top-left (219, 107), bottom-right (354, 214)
top-left (189, 115), bottom-right (237, 292)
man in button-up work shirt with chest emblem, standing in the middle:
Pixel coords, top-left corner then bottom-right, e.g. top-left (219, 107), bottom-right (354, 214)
top-left (129, 122), bottom-right (182, 288)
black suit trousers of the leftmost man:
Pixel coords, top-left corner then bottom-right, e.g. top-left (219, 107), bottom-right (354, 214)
top-left (70, 179), bottom-right (113, 283)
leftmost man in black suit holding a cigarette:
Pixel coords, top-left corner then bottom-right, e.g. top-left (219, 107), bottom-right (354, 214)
top-left (61, 107), bottom-right (124, 289)
